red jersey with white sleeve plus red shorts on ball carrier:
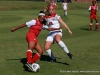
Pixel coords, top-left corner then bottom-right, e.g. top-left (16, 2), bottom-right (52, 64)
top-left (26, 19), bottom-right (43, 42)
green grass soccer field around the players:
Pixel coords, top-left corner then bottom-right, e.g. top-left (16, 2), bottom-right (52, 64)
top-left (0, 1), bottom-right (100, 75)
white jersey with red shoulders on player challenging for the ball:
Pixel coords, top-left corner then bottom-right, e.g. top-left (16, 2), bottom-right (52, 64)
top-left (45, 13), bottom-right (62, 32)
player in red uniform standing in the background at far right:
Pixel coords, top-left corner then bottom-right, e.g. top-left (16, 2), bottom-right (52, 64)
top-left (89, 0), bottom-right (98, 31)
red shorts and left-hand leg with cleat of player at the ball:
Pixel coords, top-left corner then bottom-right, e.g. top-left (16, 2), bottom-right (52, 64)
top-left (25, 32), bottom-right (37, 71)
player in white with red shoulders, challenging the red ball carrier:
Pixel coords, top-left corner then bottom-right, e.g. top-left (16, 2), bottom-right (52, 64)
top-left (44, 6), bottom-right (73, 62)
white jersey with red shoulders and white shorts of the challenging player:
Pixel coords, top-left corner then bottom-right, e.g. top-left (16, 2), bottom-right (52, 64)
top-left (45, 13), bottom-right (62, 42)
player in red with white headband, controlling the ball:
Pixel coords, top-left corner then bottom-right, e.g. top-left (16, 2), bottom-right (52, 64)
top-left (11, 13), bottom-right (45, 71)
